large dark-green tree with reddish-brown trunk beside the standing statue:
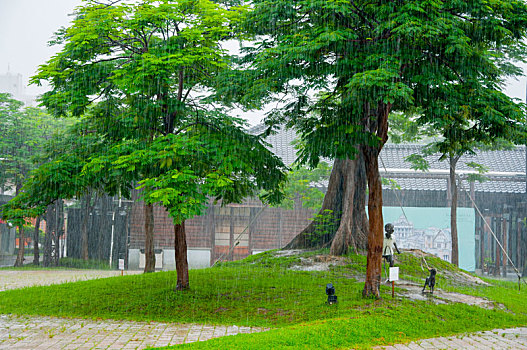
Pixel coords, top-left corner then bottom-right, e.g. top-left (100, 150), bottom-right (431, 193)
top-left (228, 0), bottom-right (527, 297)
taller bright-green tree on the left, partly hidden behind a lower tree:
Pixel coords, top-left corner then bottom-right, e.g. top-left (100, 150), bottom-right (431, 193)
top-left (33, 0), bottom-right (250, 271)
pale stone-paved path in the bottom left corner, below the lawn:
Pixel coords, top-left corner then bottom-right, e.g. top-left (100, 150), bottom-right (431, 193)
top-left (0, 315), bottom-right (263, 350)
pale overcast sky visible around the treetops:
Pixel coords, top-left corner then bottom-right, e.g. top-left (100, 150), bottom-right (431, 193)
top-left (0, 0), bottom-right (526, 124)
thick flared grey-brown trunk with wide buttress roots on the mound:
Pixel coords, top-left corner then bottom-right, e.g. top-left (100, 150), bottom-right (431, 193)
top-left (285, 154), bottom-right (367, 255)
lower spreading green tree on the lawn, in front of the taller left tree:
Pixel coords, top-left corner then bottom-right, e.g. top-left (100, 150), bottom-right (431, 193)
top-left (109, 121), bottom-right (285, 290)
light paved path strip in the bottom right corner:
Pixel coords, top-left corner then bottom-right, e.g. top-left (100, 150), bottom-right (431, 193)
top-left (376, 327), bottom-right (527, 350)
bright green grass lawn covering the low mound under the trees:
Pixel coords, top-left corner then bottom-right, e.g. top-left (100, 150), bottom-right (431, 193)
top-left (0, 252), bottom-right (527, 349)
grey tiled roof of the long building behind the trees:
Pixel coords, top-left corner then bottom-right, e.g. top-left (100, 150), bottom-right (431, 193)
top-left (253, 125), bottom-right (525, 193)
